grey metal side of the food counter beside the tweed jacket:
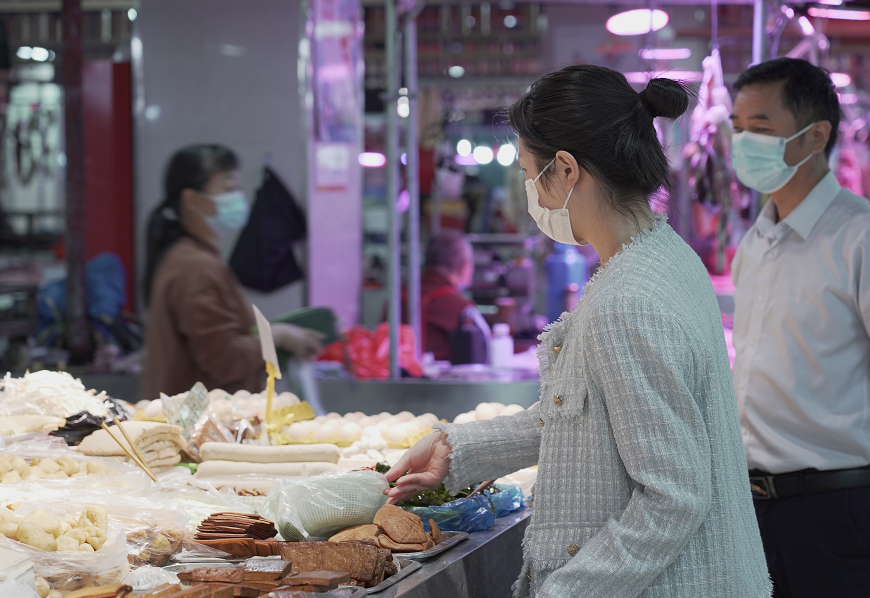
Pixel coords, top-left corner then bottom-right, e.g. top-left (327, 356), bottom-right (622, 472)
top-left (384, 509), bottom-right (532, 598)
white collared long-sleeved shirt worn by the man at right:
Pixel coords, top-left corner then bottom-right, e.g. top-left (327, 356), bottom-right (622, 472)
top-left (732, 172), bottom-right (870, 473)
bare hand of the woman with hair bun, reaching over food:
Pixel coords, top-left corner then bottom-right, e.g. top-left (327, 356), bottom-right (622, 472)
top-left (384, 430), bottom-right (450, 505)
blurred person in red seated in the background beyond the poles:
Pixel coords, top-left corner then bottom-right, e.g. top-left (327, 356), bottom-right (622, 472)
top-left (420, 229), bottom-right (474, 361)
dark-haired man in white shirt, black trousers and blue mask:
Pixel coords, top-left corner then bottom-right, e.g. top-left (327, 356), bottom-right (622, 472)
top-left (732, 58), bottom-right (870, 598)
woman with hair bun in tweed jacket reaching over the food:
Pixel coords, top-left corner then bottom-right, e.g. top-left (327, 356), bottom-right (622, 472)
top-left (387, 65), bottom-right (771, 598)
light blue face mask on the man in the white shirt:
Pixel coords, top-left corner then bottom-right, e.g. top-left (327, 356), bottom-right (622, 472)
top-left (731, 123), bottom-right (816, 193)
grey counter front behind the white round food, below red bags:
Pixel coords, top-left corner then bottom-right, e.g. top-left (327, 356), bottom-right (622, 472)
top-left (318, 378), bottom-right (540, 421)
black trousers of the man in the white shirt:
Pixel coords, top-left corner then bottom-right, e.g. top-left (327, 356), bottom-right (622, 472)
top-left (754, 488), bottom-right (870, 598)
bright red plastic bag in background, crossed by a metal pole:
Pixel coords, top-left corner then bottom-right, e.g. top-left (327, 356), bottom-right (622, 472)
top-left (318, 324), bottom-right (423, 380)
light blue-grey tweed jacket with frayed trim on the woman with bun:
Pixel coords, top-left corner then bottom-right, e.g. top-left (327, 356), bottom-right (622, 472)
top-left (436, 218), bottom-right (771, 598)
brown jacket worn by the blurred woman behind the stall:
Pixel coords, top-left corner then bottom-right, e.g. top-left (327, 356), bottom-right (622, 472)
top-left (139, 238), bottom-right (265, 400)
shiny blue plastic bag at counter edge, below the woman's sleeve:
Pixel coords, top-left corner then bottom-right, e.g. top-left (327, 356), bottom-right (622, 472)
top-left (405, 485), bottom-right (525, 533)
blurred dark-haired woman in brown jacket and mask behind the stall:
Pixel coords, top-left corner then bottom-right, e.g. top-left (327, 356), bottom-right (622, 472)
top-left (139, 144), bottom-right (320, 400)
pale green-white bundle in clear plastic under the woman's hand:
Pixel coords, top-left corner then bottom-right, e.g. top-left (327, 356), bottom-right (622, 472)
top-left (261, 471), bottom-right (389, 542)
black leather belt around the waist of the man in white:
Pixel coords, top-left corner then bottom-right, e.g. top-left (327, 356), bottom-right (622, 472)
top-left (749, 465), bottom-right (870, 500)
